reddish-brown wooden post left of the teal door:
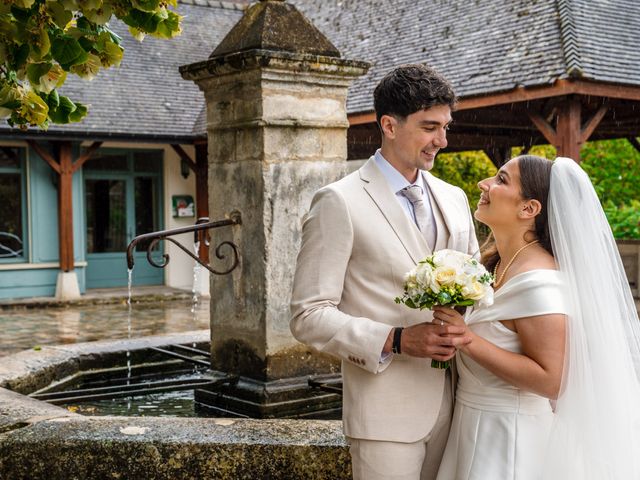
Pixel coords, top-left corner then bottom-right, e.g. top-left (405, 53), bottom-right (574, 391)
top-left (58, 142), bottom-right (74, 272)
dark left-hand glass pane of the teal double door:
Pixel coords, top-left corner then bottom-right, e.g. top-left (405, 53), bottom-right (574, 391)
top-left (85, 180), bottom-right (127, 253)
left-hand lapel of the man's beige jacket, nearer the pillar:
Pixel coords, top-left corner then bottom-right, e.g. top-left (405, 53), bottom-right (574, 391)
top-left (359, 157), bottom-right (429, 263)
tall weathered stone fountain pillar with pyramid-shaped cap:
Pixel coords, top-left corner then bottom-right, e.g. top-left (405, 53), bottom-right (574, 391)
top-left (180, 0), bottom-right (368, 416)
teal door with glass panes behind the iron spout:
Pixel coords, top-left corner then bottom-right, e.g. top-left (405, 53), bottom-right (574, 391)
top-left (83, 149), bottom-right (164, 288)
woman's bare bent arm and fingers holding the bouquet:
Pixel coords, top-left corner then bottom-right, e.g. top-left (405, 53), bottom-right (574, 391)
top-left (434, 308), bottom-right (565, 399)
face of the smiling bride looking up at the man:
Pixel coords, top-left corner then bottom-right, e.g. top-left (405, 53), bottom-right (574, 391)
top-left (474, 158), bottom-right (524, 228)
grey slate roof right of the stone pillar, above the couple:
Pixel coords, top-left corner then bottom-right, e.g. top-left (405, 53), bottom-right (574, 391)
top-left (291, 0), bottom-right (640, 113)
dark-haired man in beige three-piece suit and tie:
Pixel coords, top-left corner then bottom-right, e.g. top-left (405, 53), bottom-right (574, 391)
top-left (291, 65), bottom-right (478, 480)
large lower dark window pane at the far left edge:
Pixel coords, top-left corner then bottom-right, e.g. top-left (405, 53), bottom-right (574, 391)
top-left (0, 173), bottom-right (23, 258)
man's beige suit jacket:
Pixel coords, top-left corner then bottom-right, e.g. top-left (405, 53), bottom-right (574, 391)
top-left (291, 158), bottom-right (478, 442)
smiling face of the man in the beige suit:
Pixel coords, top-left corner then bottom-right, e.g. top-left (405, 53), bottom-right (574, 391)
top-left (383, 105), bottom-right (451, 174)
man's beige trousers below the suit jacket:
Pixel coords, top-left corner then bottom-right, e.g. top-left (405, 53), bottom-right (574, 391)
top-left (347, 372), bottom-right (453, 480)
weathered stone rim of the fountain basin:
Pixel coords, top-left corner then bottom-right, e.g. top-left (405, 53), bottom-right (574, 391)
top-left (0, 330), bottom-right (351, 480)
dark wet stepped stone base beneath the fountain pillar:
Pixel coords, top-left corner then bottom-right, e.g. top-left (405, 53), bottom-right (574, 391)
top-left (195, 374), bottom-right (342, 420)
